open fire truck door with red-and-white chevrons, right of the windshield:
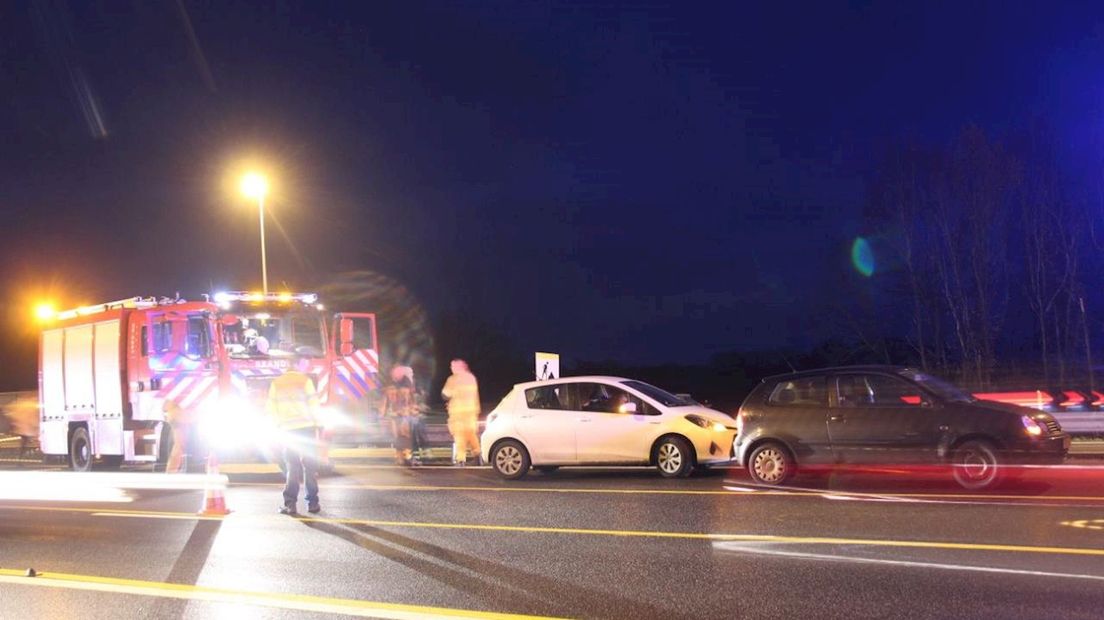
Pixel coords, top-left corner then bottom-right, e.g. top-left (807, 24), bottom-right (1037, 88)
top-left (329, 312), bottom-right (380, 400)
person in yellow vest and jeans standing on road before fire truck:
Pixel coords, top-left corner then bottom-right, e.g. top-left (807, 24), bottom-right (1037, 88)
top-left (267, 357), bottom-right (321, 514)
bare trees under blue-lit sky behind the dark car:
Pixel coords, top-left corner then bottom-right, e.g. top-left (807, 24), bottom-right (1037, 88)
top-left (866, 127), bottom-right (1094, 387)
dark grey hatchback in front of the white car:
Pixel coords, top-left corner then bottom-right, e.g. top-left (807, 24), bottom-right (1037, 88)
top-left (735, 366), bottom-right (1070, 489)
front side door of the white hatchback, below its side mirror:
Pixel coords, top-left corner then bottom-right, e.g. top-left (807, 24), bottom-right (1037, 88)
top-left (575, 383), bottom-right (660, 463)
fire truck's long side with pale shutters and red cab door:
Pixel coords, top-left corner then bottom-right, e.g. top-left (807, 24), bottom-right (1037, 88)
top-left (39, 297), bottom-right (229, 471)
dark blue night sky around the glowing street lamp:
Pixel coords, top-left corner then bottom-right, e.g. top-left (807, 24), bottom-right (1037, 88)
top-left (0, 0), bottom-right (1104, 390)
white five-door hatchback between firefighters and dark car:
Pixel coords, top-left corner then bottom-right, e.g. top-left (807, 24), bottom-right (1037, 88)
top-left (481, 376), bottom-right (736, 480)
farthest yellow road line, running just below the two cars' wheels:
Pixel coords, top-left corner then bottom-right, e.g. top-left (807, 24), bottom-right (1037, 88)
top-left (231, 482), bottom-right (1104, 502)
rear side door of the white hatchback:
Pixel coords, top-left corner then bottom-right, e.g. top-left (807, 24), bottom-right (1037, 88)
top-left (514, 384), bottom-right (578, 464)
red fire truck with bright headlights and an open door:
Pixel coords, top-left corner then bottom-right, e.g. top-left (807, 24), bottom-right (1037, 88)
top-left (39, 292), bottom-right (380, 471)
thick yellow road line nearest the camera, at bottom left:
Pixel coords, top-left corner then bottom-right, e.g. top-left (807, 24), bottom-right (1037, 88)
top-left (0, 568), bottom-right (565, 620)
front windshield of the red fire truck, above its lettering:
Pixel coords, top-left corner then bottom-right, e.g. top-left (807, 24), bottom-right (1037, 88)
top-left (222, 308), bottom-right (326, 359)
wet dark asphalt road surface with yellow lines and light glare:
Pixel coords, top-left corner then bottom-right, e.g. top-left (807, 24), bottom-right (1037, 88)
top-left (0, 464), bottom-right (1104, 619)
